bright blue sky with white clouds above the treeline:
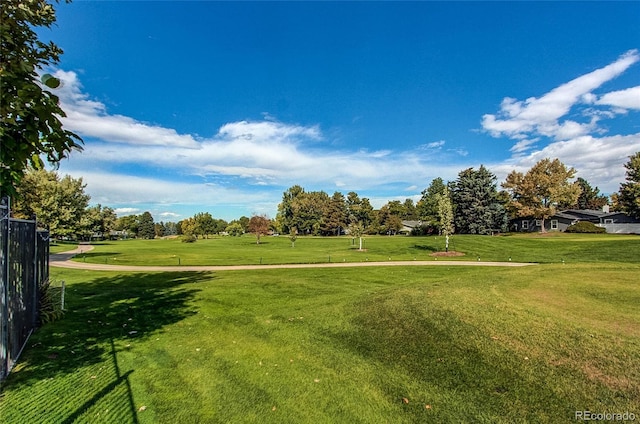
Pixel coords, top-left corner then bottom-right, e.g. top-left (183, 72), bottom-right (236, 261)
top-left (39, 0), bottom-right (640, 221)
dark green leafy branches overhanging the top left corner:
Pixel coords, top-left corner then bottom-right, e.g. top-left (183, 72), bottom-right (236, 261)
top-left (0, 0), bottom-right (82, 196)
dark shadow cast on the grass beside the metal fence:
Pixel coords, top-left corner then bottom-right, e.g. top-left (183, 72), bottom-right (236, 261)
top-left (1, 272), bottom-right (214, 423)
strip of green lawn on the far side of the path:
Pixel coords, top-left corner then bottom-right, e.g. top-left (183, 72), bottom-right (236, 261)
top-left (71, 233), bottom-right (640, 265)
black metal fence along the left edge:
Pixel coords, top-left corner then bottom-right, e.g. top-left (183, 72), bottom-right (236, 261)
top-left (0, 198), bottom-right (49, 381)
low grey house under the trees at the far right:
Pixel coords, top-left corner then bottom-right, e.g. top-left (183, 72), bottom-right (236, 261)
top-left (510, 206), bottom-right (640, 234)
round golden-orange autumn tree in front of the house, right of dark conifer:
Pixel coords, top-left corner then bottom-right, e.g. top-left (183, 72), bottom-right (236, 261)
top-left (502, 159), bottom-right (580, 232)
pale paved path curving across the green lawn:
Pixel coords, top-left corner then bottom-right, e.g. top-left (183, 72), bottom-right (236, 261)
top-left (49, 245), bottom-right (536, 272)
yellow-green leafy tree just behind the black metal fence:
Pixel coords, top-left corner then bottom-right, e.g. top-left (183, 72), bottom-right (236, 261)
top-left (13, 169), bottom-right (90, 238)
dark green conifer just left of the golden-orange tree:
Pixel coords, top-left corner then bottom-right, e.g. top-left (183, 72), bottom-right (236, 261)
top-left (451, 165), bottom-right (507, 234)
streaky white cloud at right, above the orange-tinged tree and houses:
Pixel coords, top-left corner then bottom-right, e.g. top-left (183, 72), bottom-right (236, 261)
top-left (482, 50), bottom-right (640, 193)
